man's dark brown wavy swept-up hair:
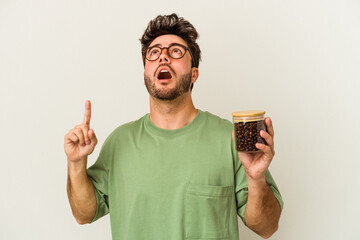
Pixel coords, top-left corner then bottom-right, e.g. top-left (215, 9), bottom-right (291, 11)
top-left (140, 13), bottom-right (201, 68)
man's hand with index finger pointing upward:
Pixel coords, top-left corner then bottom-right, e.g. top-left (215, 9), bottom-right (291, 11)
top-left (64, 100), bottom-right (97, 163)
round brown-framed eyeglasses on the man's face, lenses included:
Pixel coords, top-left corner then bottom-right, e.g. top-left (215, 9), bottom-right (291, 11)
top-left (145, 43), bottom-right (193, 61)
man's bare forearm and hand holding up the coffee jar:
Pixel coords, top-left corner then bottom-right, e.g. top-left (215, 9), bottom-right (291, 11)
top-left (238, 118), bottom-right (281, 238)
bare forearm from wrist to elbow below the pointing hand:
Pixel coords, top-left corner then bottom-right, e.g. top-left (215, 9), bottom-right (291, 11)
top-left (67, 160), bottom-right (97, 224)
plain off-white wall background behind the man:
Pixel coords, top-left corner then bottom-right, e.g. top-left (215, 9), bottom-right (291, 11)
top-left (0, 0), bottom-right (360, 240)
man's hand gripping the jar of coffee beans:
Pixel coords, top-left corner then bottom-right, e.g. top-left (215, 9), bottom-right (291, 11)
top-left (233, 117), bottom-right (275, 181)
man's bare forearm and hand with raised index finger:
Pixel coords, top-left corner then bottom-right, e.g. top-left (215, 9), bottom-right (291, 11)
top-left (64, 101), bottom-right (97, 224)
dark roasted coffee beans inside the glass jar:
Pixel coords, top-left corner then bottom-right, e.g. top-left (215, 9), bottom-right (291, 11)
top-left (234, 120), bottom-right (266, 152)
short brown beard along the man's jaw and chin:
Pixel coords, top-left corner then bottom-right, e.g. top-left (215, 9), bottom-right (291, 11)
top-left (144, 71), bottom-right (191, 101)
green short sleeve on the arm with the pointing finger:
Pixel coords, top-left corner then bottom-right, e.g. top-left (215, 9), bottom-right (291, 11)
top-left (87, 134), bottom-right (111, 222)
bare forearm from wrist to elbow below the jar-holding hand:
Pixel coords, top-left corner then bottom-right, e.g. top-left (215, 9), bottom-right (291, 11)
top-left (245, 176), bottom-right (281, 238)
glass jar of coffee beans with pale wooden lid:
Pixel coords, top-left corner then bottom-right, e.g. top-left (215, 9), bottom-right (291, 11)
top-left (232, 110), bottom-right (266, 153)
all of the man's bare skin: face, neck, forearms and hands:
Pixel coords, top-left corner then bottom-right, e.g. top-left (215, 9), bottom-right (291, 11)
top-left (64, 35), bottom-right (280, 238)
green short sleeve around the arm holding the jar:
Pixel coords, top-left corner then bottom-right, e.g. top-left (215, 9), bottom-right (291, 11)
top-left (233, 141), bottom-right (284, 222)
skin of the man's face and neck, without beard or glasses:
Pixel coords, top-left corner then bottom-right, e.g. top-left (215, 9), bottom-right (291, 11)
top-left (144, 35), bottom-right (199, 129)
